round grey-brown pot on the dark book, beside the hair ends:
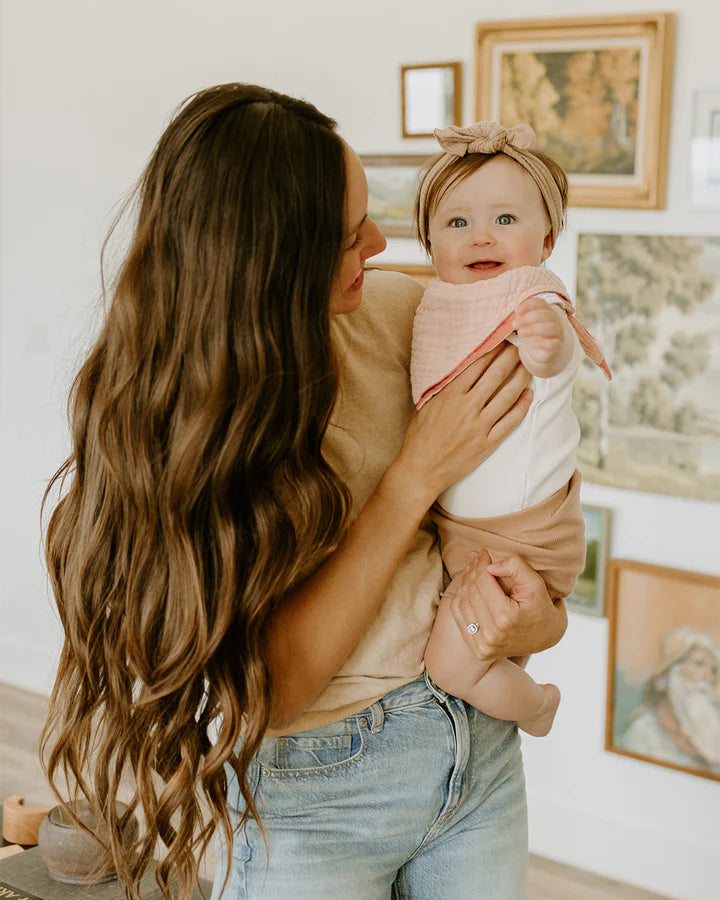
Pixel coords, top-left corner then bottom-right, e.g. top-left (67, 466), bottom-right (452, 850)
top-left (38, 800), bottom-right (138, 884)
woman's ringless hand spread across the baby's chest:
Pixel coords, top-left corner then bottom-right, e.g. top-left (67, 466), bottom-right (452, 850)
top-left (388, 343), bottom-right (532, 513)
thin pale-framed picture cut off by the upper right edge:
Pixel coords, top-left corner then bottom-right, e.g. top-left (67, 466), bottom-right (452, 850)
top-left (690, 91), bottom-right (720, 209)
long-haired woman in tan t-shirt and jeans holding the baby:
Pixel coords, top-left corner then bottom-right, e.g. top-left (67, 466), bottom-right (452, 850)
top-left (40, 84), bottom-right (565, 900)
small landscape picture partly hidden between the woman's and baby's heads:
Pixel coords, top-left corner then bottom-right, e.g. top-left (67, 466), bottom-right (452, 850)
top-left (360, 154), bottom-right (434, 237)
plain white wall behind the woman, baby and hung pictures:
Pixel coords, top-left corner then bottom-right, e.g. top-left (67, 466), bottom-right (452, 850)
top-left (0, 0), bottom-right (720, 900)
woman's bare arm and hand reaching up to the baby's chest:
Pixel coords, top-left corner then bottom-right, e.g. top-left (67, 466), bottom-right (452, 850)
top-left (267, 344), bottom-right (531, 728)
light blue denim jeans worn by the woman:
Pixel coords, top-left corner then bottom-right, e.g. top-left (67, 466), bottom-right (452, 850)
top-left (212, 678), bottom-right (527, 900)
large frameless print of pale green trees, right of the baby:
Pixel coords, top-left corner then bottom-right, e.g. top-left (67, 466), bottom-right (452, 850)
top-left (573, 234), bottom-right (720, 501)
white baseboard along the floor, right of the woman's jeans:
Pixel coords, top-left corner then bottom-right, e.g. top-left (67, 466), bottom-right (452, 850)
top-left (528, 792), bottom-right (720, 900)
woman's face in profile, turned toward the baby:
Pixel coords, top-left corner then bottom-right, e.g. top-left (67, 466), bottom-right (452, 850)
top-left (330, 144), bottom-right (387, 316)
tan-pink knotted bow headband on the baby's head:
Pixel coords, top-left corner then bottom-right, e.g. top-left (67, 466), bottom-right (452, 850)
top-left (419, 122), bottom-right (563, 246)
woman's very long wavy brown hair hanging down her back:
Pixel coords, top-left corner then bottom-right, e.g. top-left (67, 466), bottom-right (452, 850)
top-left (41, 84), bottom-right (349, 898)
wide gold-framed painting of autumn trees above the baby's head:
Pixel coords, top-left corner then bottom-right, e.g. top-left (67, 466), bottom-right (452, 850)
top-left (475, 13), bottom-right (675, 209)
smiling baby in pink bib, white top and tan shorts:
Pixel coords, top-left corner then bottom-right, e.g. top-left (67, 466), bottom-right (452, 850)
top-left (411, 122), bottom-right (610, 736)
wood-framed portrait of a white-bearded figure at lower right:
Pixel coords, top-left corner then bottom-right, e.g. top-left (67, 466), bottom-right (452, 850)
top-left (605, 560), bottom-right (720, 781)
